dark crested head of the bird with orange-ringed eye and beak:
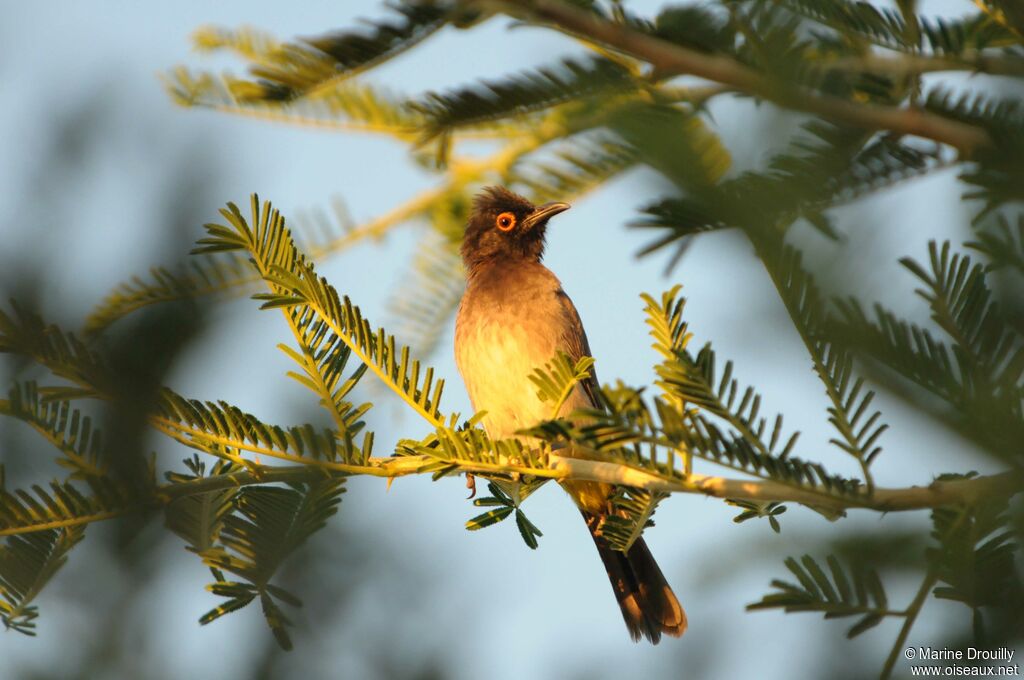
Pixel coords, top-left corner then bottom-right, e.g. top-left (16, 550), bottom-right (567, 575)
top-left (462, 186), bottom-right (569, 271)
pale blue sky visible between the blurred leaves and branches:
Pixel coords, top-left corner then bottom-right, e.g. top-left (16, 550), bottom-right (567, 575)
top-left (0, 0), bottom-right (1007, 680)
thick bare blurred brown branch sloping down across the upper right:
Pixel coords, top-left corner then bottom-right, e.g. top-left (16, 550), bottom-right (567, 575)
top-left (488, 0), bottom-right (993, 158)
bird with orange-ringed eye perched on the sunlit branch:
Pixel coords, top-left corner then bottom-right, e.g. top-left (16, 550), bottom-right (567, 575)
top-left (455, 186), bottom-right (686, 644)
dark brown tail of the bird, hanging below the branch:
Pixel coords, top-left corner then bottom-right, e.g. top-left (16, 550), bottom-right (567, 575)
top-left (587, 515), bottom-right (686, 644)
